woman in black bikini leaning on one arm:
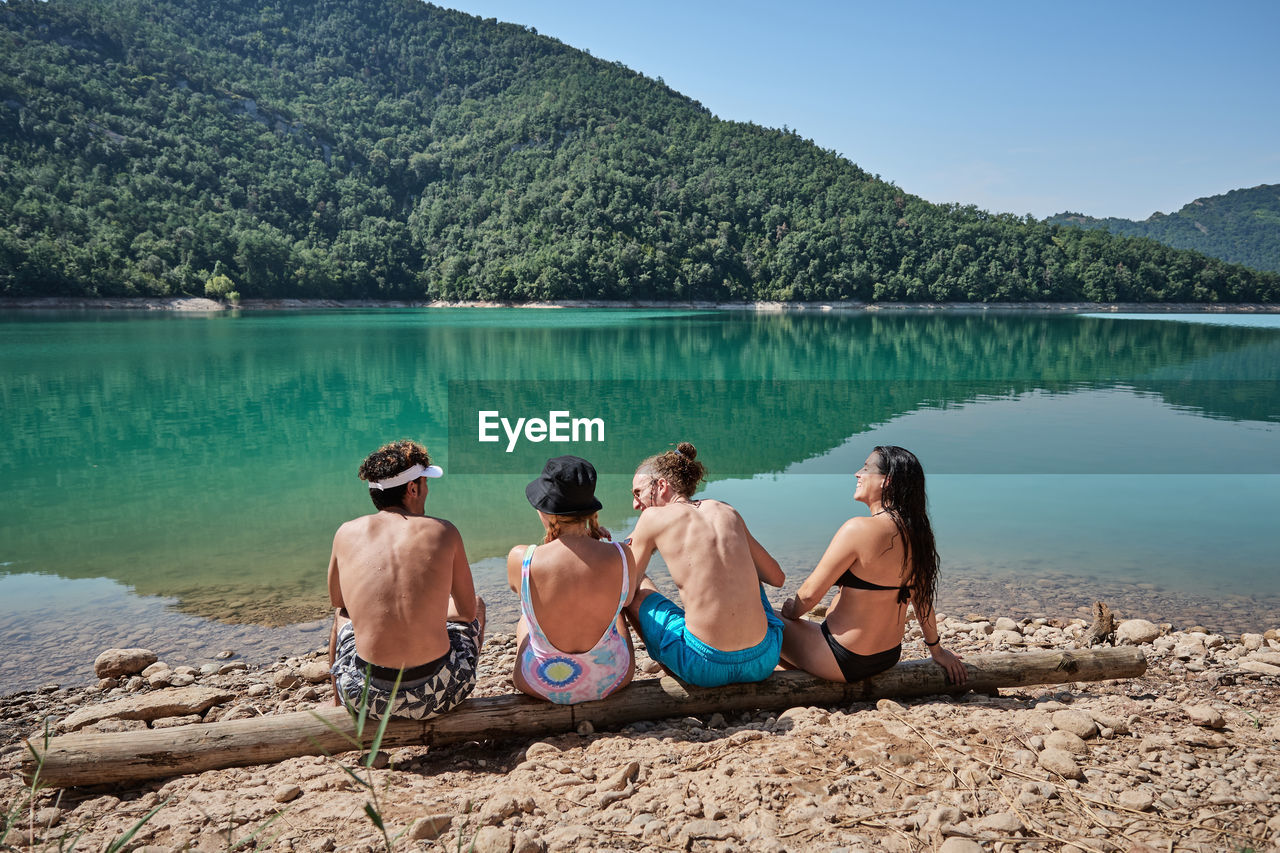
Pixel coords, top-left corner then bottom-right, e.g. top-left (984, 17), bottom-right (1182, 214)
top-left (782, 446), bottom-right (966, 684)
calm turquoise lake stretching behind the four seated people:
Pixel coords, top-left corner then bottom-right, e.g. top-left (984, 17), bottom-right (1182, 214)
top-left (0, 309), bottom-right (1280, 693)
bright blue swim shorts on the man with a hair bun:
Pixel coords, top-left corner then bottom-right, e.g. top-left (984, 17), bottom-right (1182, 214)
top-left (636, 584), bottom-right (782, 686)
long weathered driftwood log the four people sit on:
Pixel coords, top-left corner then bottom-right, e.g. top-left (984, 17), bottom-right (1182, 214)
top-left (23, 648), bottom-right (1147, 788)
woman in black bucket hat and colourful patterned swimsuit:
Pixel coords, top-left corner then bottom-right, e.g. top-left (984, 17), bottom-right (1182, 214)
top-left (507, 456), bottom-right (640, 704)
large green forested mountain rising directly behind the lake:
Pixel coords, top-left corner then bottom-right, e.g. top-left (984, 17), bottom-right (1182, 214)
top-left (0, 0), bottom-right (1280, 301)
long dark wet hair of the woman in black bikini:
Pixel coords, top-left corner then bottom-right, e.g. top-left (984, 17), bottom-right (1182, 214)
top-left (874, 444), bottom-right (938, 611)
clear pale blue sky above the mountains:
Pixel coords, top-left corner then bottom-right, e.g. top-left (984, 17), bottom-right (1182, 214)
top-left (436, 0), bottom-right (1280, 219)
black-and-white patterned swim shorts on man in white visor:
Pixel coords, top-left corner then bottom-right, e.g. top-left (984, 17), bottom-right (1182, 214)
top-left (332, 619), bottom-right (480, 720)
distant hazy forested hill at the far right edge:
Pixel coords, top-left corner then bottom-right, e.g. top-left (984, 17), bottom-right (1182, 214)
top-left (1047, 183), bottom-right (1280, 273)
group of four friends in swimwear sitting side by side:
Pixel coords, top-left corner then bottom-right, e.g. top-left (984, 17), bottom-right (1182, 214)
top-left (329, 441), bottom-right (965, 719)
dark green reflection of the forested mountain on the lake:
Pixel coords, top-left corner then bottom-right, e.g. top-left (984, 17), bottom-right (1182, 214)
top-left (0, 310), bottom-right (1280, 620)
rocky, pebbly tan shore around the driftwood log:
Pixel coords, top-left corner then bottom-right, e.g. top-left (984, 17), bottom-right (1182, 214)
top-left (0, 613), bottom-right (1280, 853)
